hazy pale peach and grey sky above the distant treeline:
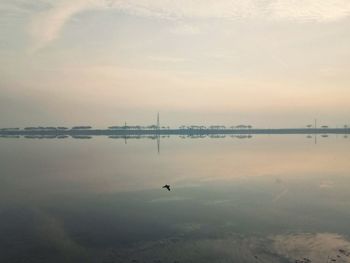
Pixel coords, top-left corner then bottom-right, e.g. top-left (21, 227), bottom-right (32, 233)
top-left (0, 0), bottom-right (350, 128)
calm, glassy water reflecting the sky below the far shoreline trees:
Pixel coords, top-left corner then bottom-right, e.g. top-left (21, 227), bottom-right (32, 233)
top-left (0, 135), bottom-right (350, 263)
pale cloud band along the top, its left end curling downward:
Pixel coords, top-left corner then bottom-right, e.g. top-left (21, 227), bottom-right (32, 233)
top-left (17, 0), bottom-right (350, 50)
